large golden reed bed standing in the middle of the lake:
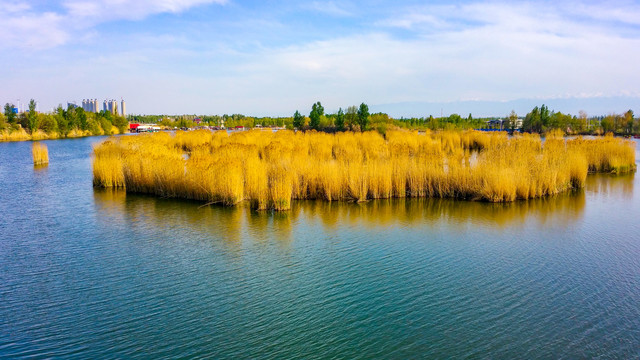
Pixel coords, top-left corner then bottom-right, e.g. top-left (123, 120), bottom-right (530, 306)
top-left (93, 130), bottom-right (635, 210)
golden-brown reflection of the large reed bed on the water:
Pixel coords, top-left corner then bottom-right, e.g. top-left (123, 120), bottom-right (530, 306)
top-left (94, 187), bottom-right (592, 243)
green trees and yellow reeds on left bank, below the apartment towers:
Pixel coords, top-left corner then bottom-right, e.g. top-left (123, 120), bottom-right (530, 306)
top-left (0, 100), bottom-right (128, 141)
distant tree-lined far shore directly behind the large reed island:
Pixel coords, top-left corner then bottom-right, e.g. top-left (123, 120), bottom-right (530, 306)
top-left (131, 101), bottom-right (640, 136)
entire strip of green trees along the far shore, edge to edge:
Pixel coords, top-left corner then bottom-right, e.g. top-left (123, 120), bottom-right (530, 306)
top-left (12, 99), bottom-right (640, 137)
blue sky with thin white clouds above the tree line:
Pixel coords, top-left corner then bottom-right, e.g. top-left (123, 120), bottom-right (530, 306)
top-left (0, 0), bottom-right (640, 117)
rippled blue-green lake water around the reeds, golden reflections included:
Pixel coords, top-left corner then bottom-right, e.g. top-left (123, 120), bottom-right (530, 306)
top-left (0, 138), bottom-right (640, 359)
